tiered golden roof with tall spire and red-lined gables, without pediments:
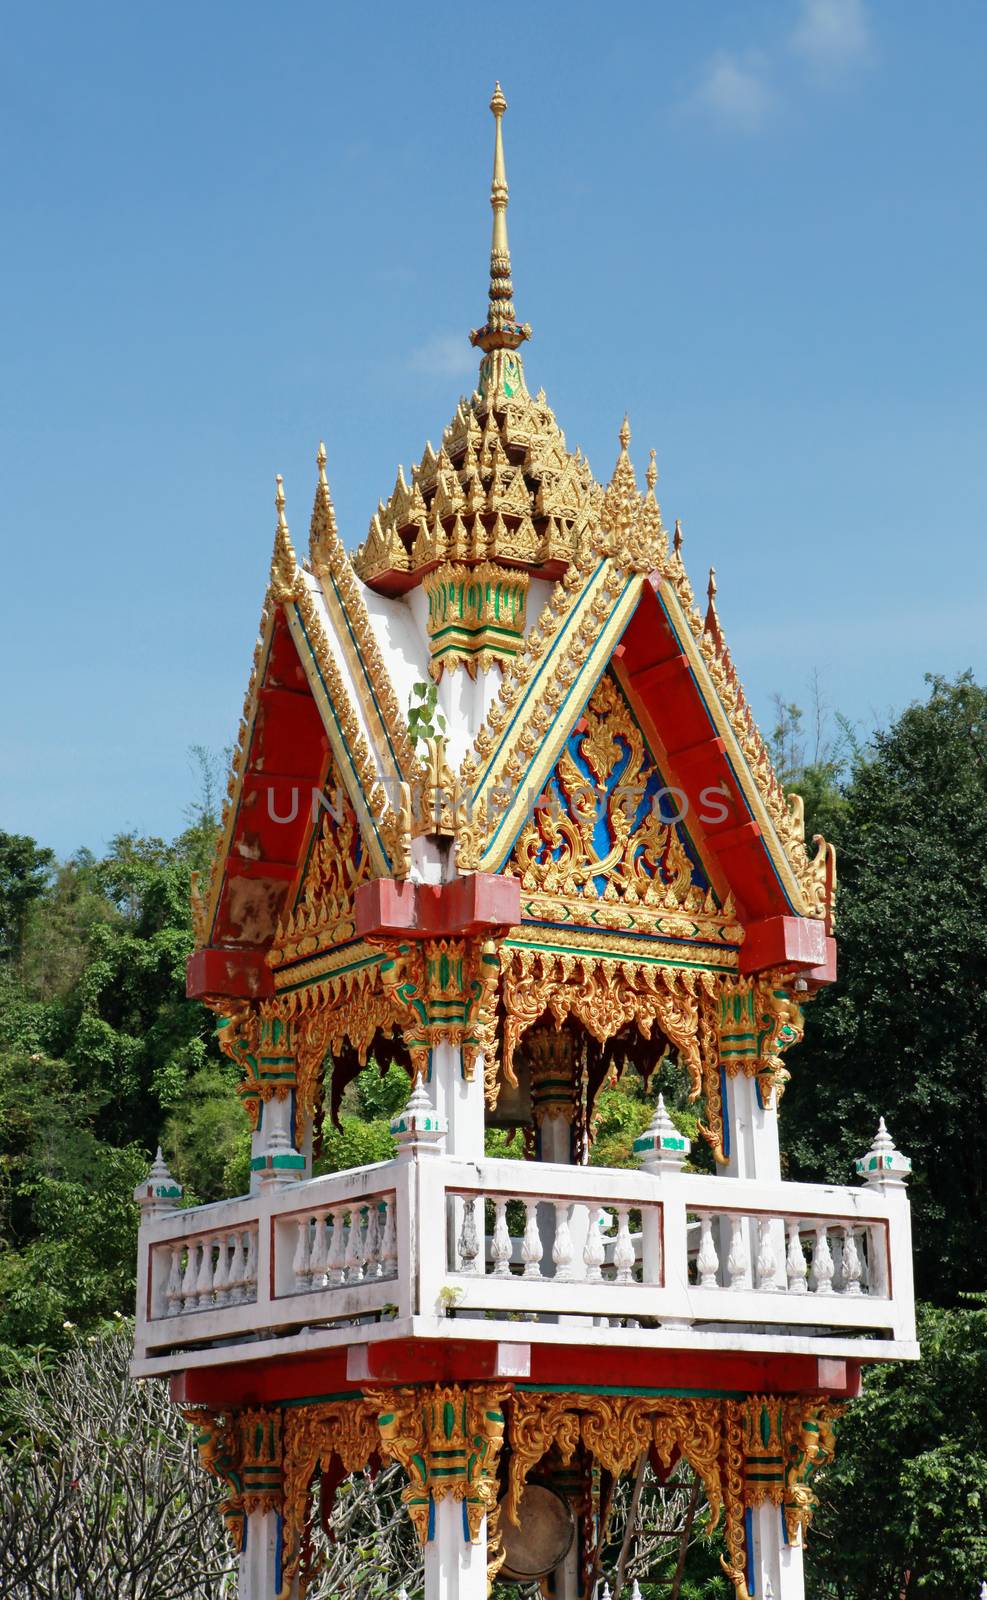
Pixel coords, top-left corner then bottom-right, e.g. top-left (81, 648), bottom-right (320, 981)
top-left (188, 85), bottom-right (835, 992)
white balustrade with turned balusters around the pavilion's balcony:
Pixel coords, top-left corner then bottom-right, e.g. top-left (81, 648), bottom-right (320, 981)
top-left (138, 1152), bottom-right (915, 1371)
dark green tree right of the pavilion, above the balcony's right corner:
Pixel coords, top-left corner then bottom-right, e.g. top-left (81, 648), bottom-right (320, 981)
top-left (781, 677), bottom-right (987, 1304)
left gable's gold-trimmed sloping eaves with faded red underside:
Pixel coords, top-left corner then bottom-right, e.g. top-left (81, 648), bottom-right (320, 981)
top-left (189, 470), bottom-right (414, 994)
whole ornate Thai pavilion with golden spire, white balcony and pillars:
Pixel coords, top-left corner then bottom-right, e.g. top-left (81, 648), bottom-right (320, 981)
top-left (134, 85), bottom-right (917, 1600)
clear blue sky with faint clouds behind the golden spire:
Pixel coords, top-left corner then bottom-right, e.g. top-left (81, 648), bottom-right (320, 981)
top-left (0, 0), bottom-right (987, 853)
